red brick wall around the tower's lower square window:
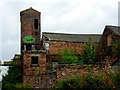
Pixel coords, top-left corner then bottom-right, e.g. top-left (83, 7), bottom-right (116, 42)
top-left (23, 53), bottom-right (46, 76)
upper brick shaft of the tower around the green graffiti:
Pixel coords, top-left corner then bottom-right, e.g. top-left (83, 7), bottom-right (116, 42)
top-left (20, 8), bottom-right (41, 50)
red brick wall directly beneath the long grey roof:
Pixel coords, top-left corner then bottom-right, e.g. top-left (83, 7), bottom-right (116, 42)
top-left (44, 41), bottom-right (84, 54)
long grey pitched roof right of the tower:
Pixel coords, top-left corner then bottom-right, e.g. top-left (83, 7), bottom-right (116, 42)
top-left (43, 32), bottom-right (101, 42)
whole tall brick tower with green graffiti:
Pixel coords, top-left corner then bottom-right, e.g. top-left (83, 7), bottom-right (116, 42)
top-left (20, 8), bottom-right (46, 87)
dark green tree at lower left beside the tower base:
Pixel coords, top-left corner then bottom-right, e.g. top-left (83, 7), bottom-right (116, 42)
top-left (2, 61), bottom-right (21, 89)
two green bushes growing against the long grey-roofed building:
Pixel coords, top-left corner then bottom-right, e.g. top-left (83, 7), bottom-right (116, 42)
top-left (59, 38), bottom-right (97, 65)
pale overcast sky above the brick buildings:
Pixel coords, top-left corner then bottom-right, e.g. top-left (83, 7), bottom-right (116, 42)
top-left (0, 0), bottom-right (119, 61)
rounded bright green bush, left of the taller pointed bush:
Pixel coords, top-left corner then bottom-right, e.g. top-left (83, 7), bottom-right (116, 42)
top-left (59, 49), bottom-right (78, 64)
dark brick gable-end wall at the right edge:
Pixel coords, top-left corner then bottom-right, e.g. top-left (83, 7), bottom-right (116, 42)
top-left (97, 28), bottom-right (120, 60)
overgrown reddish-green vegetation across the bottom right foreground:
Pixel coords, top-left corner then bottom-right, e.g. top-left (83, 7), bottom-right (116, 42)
top-left (54, 72), bottom-right (120, 88)
